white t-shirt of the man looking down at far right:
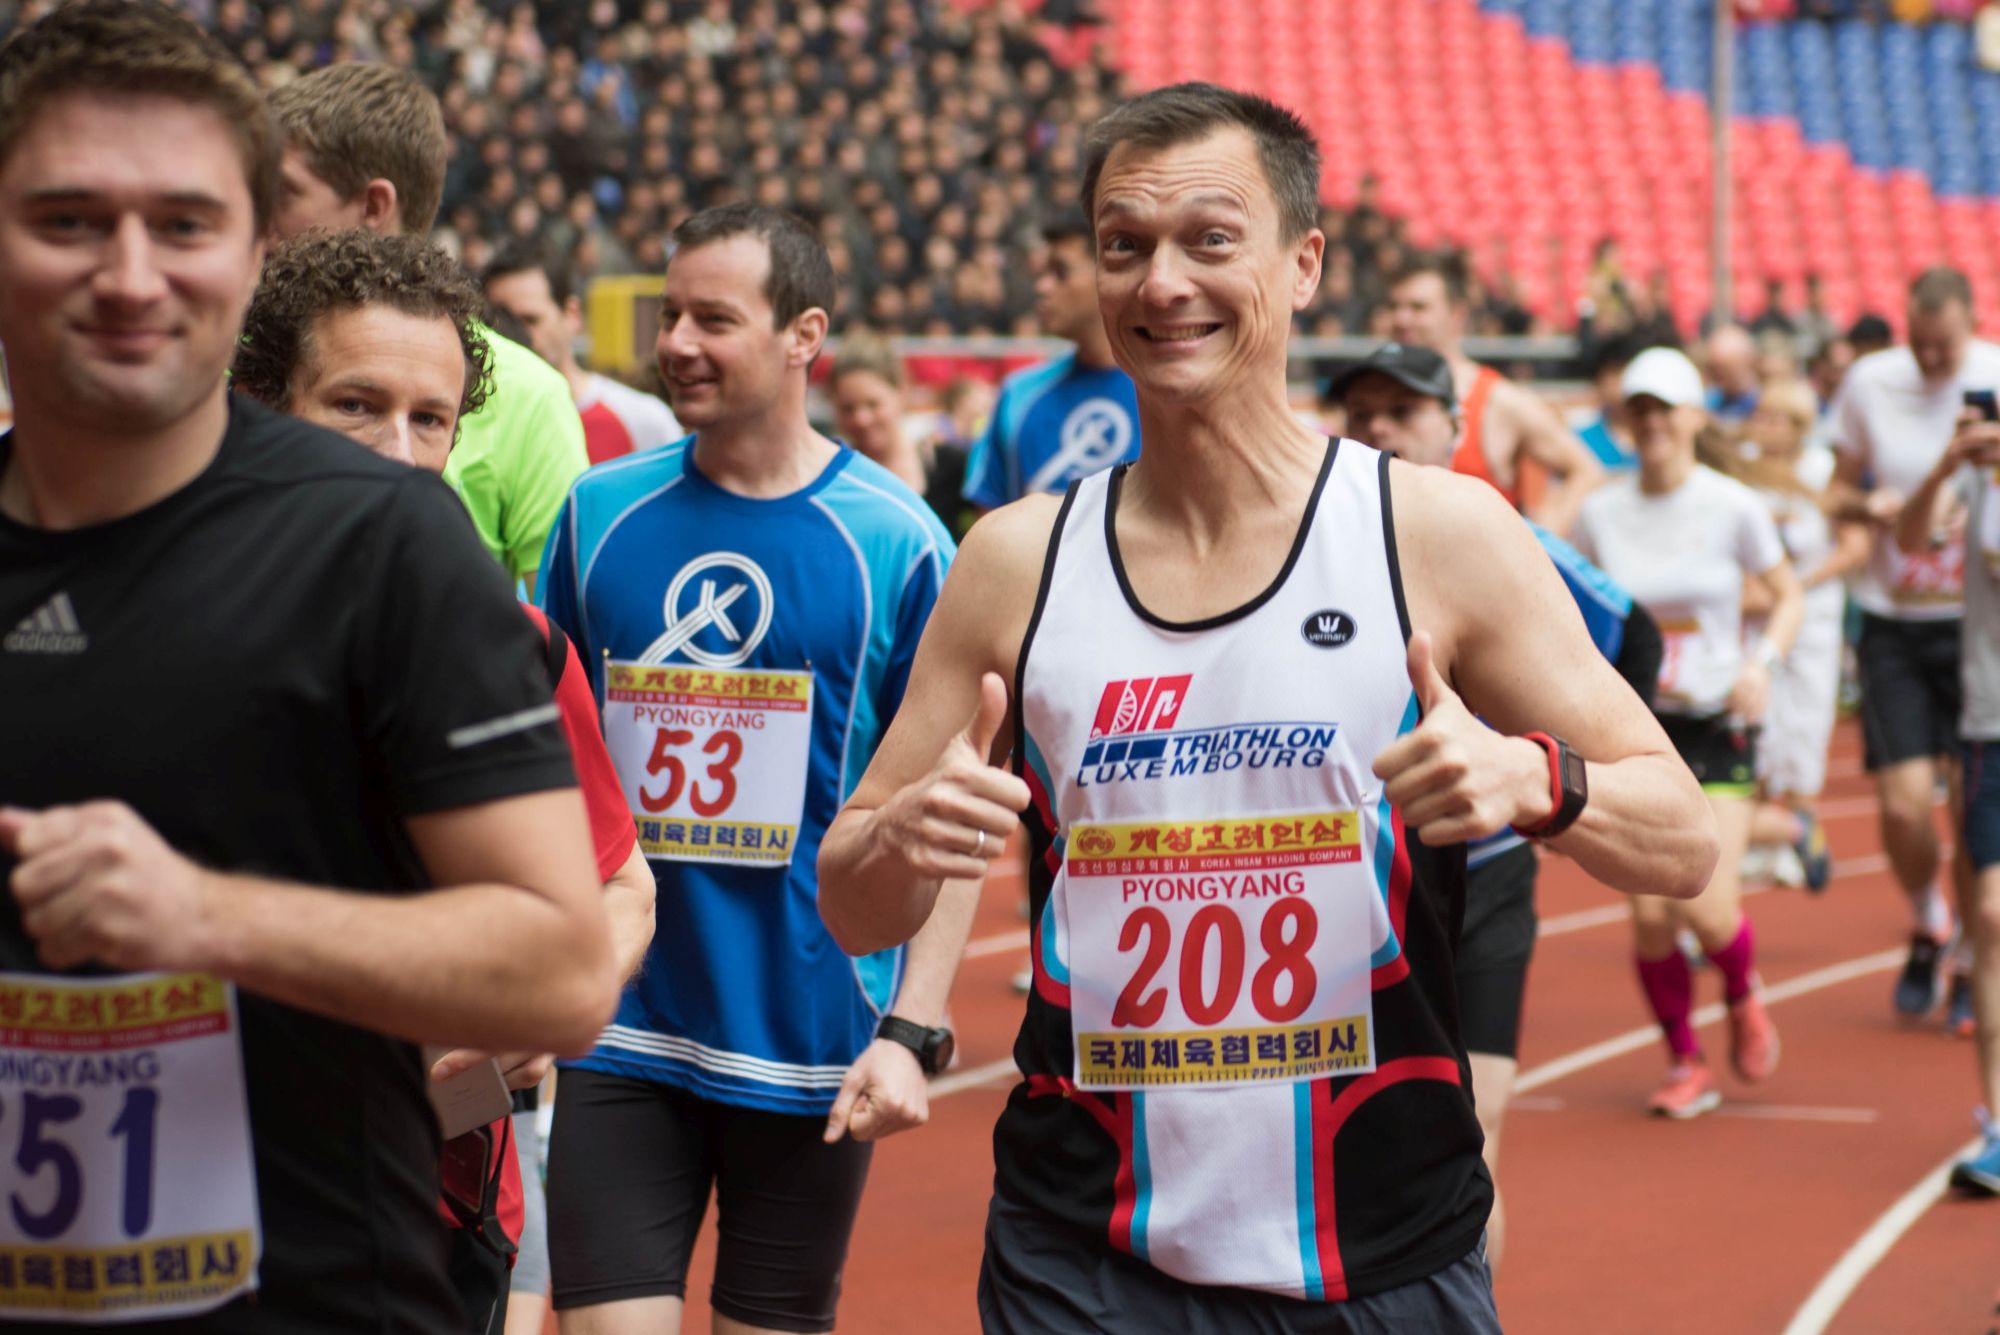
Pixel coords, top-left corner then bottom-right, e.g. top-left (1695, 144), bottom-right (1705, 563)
top-left (1834, 340), bottom-right (2000, 622)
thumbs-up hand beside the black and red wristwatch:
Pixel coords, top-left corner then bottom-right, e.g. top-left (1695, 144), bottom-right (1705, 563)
top-left (1374, 632), bottom-right (1552, 845)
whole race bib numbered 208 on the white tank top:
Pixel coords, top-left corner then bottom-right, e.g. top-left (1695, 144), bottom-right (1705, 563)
top-left (1064, 811), bottom-right (1388, 1089)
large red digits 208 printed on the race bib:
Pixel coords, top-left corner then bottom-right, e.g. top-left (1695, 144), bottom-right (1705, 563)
top-left (1112, 899), bottom-right (1320, 1029)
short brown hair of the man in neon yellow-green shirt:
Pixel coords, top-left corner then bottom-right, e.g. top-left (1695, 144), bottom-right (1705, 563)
top-left (270, 64), bottom-right (452, 236)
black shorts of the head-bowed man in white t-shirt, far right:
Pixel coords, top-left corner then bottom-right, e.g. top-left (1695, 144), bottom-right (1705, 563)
top-left (1854, 612), bottom-right (1960, 769)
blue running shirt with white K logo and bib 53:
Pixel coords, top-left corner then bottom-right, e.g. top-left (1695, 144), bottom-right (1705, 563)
top-left (542, 438), bottom-right (952, 1115)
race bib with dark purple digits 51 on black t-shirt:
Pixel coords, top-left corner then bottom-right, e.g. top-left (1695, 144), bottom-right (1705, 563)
top-left (0, 973), bottom-right (262, 1323)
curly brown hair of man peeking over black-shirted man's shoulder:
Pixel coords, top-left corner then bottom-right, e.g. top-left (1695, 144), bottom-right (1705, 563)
top-left (232, 228), bottom-right (492, 422)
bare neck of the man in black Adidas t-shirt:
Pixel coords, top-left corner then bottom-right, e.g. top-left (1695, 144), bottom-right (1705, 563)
top-left (0, 382), bottom-right (230, 532)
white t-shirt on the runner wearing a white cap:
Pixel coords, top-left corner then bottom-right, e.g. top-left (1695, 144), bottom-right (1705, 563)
top-left (1574, 466), bottom-right (1784, 717)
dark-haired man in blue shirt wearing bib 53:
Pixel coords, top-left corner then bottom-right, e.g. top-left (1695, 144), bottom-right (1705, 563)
top-left (542, 206), bottom-right (978, 1335)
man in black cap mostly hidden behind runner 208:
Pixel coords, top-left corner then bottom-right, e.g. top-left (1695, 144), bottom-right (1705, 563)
top-left (1328, 344), bottom-right (1660, 1269)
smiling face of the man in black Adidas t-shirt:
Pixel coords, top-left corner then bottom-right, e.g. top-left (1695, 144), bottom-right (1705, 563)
top-left (0, 92), bottom-right (264, 440)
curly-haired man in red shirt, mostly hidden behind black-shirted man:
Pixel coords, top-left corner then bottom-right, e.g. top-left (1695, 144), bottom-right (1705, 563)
top-left (234, 230), bottom-right (654, 1331)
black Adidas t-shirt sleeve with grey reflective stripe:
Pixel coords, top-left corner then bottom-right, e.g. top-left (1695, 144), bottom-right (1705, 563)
top-left (352, 470), bottom-right (576, 815)
